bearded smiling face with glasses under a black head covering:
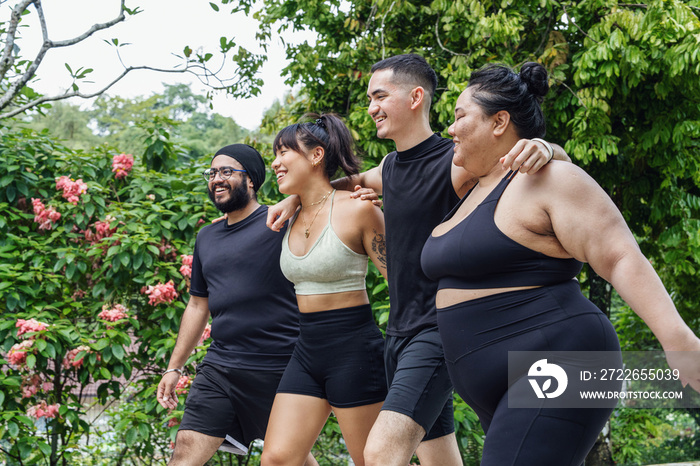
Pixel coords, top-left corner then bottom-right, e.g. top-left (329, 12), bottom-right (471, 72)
top-left (207, 155), bottom-right (253, 213)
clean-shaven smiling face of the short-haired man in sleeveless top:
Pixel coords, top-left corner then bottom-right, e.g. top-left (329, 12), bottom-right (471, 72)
top-left (367, 69), bottom-right (412, 142)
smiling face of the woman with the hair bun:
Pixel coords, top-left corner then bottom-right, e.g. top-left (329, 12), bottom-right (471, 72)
top-left (448, 87), bottom-right (499, 176)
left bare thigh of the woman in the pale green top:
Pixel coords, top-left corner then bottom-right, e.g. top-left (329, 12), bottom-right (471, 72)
top-left (263, 393), bottom-right (331, 464)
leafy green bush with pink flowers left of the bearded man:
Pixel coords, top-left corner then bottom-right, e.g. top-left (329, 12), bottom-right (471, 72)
top-left (0, 120), bottom-right (217, 465)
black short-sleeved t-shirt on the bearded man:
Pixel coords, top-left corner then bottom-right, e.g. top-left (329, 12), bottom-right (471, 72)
top-left (190, 206), bottom-right (299, 370)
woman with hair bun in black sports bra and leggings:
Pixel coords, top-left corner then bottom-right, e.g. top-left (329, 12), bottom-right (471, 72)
top-left (421, 63), bottom-right (700, 466)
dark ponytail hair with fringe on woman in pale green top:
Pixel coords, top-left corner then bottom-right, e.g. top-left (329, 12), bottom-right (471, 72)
top-left (272, 113), bottom-right (361, 179)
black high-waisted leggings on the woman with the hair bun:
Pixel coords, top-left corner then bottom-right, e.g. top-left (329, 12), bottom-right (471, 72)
top-left (438, 280), bottom-right (620, 466)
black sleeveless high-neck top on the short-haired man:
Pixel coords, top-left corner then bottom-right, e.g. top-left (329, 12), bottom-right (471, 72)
top-left (382, 134), bottom-right (459, 337)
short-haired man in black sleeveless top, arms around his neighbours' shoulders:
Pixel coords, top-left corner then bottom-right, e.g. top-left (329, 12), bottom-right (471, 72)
top-left (268, 54), bottom-right (568, 466)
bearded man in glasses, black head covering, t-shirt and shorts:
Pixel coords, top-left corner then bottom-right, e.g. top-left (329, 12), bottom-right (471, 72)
top-left (157, 144), bottom-right (318, 465)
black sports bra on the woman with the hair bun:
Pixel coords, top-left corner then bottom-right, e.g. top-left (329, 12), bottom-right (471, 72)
top-left (421, 172), bottom-right (582, 289)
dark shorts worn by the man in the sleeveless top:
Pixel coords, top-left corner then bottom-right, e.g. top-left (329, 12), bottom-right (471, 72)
top-left (382, 327), bottom-right (455, 440)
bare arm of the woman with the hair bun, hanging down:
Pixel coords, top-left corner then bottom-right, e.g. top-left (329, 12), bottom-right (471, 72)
top-left (544, 164), bottom-right (700, 391)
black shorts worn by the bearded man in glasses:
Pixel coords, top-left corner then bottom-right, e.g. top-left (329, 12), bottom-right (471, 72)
top-left (179, 361), bottom-right (282, 448)
